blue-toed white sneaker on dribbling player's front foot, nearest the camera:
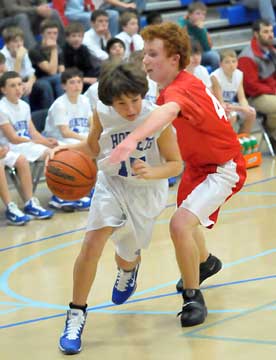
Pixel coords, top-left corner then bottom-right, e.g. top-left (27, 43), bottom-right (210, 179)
top-left (59, 309), bottom-right (87, 355)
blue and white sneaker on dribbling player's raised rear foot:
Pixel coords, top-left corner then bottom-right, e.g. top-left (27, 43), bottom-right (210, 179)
top-left (112, 264), bottom-right (139, 305)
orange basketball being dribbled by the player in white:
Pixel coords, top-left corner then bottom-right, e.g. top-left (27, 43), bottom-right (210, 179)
top-left (45, 149), bottom-right (97, 201)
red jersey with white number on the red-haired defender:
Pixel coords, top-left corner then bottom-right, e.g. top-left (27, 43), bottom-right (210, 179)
top-left (157, 71), bottom-right (240, 167)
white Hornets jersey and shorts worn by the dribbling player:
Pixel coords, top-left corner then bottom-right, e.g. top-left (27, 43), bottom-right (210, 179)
top-left (87, 100), bottom-right (168, 261)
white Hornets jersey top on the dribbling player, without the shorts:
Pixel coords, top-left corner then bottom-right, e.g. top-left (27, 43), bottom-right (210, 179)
top-left (97, 100), bottom-right (165, 184)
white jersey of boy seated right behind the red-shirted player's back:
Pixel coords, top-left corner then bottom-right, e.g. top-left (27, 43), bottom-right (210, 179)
top-left (211, 68), bottom-right (243, 103)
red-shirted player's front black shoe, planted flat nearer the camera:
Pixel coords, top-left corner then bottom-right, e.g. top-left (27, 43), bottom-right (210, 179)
top-left (177, 289), bottom-right (207, 327)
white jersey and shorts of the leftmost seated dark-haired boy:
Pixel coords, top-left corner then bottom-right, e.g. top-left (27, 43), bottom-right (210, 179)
top-left (0, 97), bottom-right (48, 163)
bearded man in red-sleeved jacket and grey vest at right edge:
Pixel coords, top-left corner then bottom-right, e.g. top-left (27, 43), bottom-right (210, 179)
top-left (238, 20), bottom-right (276, 150)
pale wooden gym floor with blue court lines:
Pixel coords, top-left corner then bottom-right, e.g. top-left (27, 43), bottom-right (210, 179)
top-left (0, 158), bottom-right (276, 360)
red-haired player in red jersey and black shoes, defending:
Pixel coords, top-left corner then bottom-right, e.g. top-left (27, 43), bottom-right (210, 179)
top-left (110, 23), bottom-right (246, 327)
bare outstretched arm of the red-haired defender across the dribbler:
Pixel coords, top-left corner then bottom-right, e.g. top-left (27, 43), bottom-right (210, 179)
top-left (110, 102), bottom-right (180, 164)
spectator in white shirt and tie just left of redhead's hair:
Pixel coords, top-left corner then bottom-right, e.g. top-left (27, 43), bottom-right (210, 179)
top-left (116, 12), bottom-right (144, 58)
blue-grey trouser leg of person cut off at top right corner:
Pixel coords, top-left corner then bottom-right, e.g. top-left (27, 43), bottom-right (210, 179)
top-left (239, 0), bottom-right (276, 35)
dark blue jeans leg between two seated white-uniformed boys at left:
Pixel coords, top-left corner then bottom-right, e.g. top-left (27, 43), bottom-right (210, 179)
top-left (30, 79), bottom-right (55, 111)
